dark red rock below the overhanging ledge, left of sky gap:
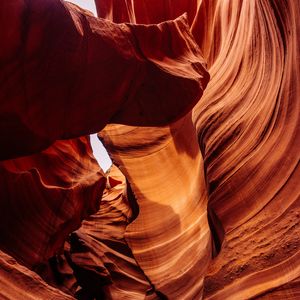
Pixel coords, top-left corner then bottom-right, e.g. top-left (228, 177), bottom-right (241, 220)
top-left (0, 138), bottom-right (106, 269)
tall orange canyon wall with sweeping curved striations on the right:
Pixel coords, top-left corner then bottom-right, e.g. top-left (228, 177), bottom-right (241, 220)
top-left (194, 1), bottom-right (300, 299)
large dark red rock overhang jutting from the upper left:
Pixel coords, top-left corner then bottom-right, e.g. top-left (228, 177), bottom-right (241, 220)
top-left (0, 0), bottom-right (205, 160)
